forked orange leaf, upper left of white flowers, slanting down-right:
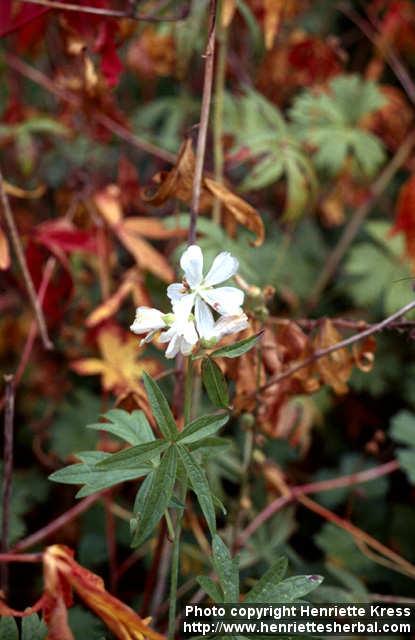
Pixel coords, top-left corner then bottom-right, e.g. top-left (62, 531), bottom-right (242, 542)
top-left (94, 184), bottom-right (179, 282)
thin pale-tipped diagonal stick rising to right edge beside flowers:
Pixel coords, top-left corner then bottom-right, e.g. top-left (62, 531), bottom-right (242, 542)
top-left (258, 300), bottom-right (415, 395)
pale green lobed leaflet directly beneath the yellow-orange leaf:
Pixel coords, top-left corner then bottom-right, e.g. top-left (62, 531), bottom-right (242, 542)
top-left (87, 409), bottom-right (154, 445)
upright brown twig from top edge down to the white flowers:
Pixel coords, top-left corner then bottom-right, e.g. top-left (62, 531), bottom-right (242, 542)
top-left (188, 0), bottom-right (216, 245)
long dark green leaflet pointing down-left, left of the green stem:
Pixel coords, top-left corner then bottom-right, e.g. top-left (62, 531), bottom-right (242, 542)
top-left (132, 446), bottom-right (177, 547)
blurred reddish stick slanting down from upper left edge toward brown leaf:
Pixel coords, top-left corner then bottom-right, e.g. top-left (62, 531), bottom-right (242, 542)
top-left (4, 53), bottom-right (177, 164)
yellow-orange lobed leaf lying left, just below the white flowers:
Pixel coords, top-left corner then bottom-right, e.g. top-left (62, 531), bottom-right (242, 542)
top-left (71, 325), bottom-right (159, 398)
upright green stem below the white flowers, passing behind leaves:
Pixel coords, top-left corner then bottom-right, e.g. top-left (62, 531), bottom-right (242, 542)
top-left (167, 356), bottom-right (193, 640)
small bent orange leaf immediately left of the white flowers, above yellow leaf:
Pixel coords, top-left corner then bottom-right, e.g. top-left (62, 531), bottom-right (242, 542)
top-left (85, 268), bottom-right (150, 327)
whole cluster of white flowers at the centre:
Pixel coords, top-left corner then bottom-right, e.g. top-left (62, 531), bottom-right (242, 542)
top-left (130, 244), bottom-right (248, 358)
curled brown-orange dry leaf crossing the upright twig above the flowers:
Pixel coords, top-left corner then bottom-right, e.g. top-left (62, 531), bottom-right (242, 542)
top-left (143, 138), bottom-right (265, 246)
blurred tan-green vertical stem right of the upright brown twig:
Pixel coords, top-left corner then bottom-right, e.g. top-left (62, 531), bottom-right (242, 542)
top-left (213, 3), bottom-right (228, 224)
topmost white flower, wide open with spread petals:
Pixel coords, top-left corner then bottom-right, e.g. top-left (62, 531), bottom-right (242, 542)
top-left (167, 244), bottom-right (244, 337)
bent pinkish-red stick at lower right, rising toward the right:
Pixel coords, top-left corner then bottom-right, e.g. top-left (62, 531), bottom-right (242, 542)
top-left (238, 460), bottom-right (399, 546)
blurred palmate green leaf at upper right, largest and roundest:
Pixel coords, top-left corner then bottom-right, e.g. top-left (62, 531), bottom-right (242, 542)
top-left (290, 75), bottom-right (386, 176)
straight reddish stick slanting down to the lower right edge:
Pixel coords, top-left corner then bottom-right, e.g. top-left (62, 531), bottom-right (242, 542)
top-left (297, 495), bottom-right (415, 578)
